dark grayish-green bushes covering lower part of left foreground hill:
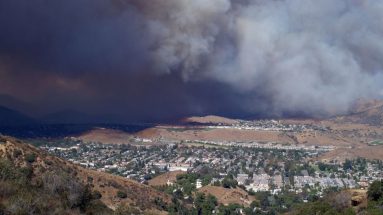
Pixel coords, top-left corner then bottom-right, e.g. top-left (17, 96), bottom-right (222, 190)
top-left (0, 157), bottom-right (113, 214)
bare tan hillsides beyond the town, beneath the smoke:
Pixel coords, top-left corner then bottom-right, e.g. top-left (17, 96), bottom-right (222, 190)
top-left (68, 100), bottom-right (383, 161)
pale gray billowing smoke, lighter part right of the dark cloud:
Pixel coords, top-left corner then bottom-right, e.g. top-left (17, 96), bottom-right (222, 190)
top-left (140, 0), bottom-right (383, 116)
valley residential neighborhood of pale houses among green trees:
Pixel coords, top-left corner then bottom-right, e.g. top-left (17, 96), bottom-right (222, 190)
top-left (41, 138), bottom-right (383, 196)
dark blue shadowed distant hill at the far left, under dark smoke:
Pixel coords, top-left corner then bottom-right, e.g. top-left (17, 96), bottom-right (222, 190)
top-left (0, 106), bottom-right (38, 127)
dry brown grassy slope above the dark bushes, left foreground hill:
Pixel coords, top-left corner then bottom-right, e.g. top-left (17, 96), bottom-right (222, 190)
top-left (0, 137), bottom-right (170, 213)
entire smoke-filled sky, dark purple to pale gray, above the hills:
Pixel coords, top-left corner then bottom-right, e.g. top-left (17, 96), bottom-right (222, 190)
top-left (0, 0), bottom-right (383, 122)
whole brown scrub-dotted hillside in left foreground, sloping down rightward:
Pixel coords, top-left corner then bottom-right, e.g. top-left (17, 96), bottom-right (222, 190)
top-left (0, 137), bottom-right (170, 214)
